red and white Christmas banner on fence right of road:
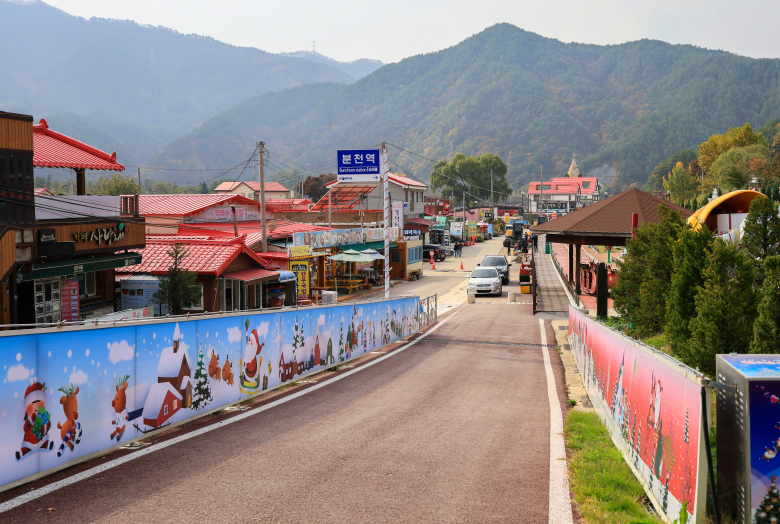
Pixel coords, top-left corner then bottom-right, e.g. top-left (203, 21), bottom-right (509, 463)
top-left (569, 307), bottom-right (707, 522)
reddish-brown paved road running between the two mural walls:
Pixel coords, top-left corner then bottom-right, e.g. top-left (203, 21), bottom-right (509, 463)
top-left (0, 235), bottom-right (572, 524)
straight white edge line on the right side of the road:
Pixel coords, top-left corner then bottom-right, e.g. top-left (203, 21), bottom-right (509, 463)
top-left (539, 318), bottom-right (574, 524)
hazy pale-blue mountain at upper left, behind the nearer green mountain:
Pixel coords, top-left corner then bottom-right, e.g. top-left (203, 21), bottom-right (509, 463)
top-left (0, 1), bottom-right (354, 135)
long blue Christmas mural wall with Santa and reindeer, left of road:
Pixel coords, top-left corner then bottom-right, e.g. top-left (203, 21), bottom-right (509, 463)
top-left (0, 297), bottom-right (419, 485)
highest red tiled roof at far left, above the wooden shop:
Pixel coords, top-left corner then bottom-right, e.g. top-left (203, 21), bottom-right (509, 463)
top-left (33, 119), bottom-right (125, 171)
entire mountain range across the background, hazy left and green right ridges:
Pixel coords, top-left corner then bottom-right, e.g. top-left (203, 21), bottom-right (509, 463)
top-left (0, 2), bottom-right (780, 189)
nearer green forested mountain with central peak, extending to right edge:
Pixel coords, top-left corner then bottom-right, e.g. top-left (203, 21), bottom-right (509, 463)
top-left (152, 24), bottom-right (780, 187)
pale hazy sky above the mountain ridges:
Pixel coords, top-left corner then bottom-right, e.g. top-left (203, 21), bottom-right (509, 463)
top-left (42, 0), bottom-right (780, 62)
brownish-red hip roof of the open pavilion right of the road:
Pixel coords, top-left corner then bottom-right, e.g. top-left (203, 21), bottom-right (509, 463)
top-left (532, 189), bottom-right (693, 237)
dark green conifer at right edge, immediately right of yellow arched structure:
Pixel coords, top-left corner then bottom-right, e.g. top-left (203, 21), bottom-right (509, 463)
top-left (742, 195), bottom-right (780, 289)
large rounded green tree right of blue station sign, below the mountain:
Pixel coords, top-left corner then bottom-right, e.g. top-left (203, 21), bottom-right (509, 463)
top-left (430, 153), bottom-right (512, 203)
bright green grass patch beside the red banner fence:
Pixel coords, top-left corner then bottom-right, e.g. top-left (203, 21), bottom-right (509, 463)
top-left (565, 411), bottom-right (662, 524)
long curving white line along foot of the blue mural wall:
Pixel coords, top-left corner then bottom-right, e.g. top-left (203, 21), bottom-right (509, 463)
top-left (0, 314), bottom-right (455, 513)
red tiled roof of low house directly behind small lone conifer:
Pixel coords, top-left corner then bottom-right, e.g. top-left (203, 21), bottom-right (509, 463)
top-left (115, 236), bottom-right (266, 276)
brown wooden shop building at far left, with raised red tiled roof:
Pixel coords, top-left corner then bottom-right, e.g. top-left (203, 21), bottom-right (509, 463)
top-left (0, 113), bottom-right (145, 324)
